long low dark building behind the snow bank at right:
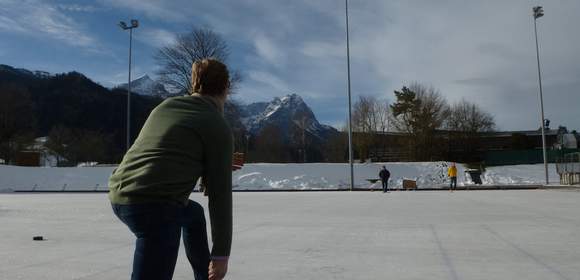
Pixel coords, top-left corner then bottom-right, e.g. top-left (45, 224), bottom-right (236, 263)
top-left (369, 127), bottom-right (578, 165)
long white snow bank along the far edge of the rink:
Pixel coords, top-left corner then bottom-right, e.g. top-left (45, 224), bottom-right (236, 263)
top-left (0, 162), bottom-right (559, 192)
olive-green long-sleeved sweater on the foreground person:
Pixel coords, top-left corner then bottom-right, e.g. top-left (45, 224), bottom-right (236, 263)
top-left (109, 96), bottom-right (233, 256)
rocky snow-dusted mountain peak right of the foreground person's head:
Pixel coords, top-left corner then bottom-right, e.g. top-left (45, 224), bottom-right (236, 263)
top-left (241, 94), bottom-right (336, 140)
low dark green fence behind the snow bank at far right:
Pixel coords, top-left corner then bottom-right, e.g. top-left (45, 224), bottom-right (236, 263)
top-left (483, 149), bottom-right (580, 166)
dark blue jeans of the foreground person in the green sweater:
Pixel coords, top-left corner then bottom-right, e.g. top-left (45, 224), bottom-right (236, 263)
top-left (112, 200), bottom-right (210, 280)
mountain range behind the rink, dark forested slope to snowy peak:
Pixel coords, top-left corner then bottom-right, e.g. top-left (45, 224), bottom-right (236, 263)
top-left (0, 64), bottom-right (338, 162)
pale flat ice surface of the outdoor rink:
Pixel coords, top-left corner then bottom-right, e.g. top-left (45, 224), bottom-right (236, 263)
top-left (0, 190), bottom-right (580, 280)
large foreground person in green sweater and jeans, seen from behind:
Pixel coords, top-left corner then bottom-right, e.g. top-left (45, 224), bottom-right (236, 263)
top-left (109, 59), bottom-right (233, 280)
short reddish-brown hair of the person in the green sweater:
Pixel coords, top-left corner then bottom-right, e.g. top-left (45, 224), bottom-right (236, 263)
top-left (191, 58), bottom-right (230, 96)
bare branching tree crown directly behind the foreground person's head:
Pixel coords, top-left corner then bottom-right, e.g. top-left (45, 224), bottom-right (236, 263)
top-left (154, 27), bottom-right (241, 93)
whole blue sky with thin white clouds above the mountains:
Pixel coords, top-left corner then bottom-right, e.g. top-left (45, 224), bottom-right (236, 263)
top-left (0, 0), bottom-right (580, 130)
